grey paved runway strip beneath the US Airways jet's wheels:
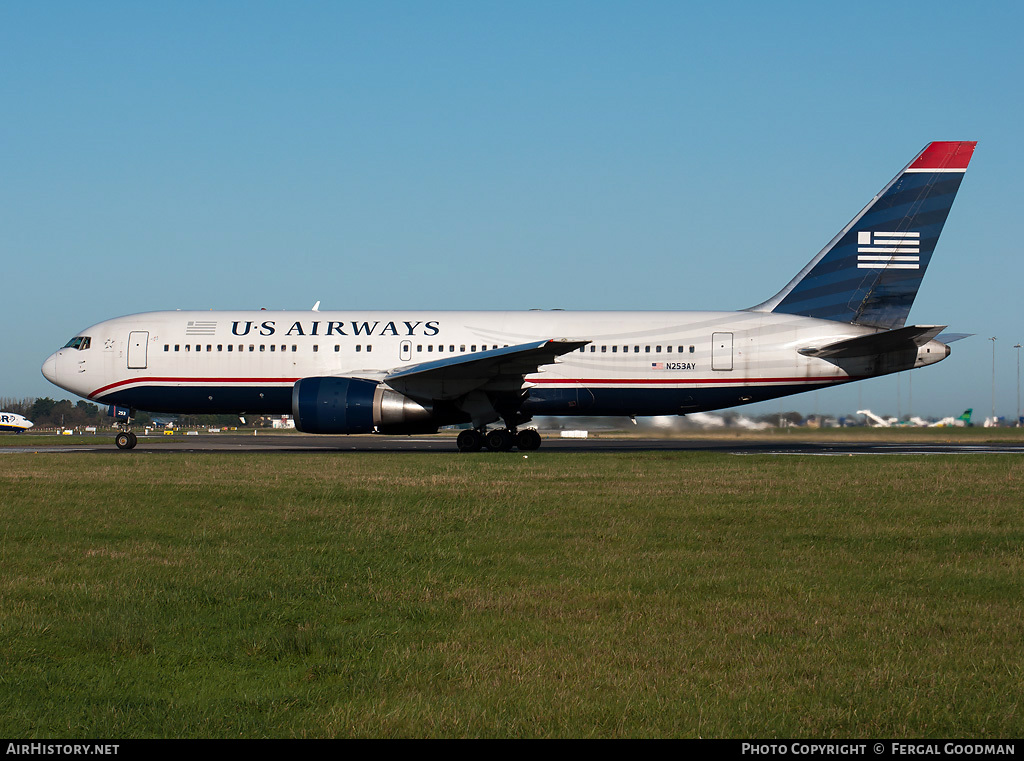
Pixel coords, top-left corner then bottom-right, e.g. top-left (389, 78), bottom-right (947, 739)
top-left (8, 433), bottom-right (1024, 457)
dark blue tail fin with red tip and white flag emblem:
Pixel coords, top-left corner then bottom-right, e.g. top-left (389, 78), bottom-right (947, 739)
top-left (751, 141), bottom-right (977, 330)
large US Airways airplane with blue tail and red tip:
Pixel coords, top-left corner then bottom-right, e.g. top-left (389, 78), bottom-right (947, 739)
top-left (42, 141), bottom-right (977, 452)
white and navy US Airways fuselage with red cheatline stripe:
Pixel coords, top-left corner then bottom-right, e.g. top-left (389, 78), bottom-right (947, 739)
top-left (43, 310), bottom-right (948, 415)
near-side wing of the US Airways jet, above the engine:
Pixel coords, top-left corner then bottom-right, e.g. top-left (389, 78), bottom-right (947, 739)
top-left (383, 338), bottom-right (590, 399)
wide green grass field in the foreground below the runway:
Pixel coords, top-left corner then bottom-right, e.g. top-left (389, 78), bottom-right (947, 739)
top-left (0, 451), bottom-right (1024, 738)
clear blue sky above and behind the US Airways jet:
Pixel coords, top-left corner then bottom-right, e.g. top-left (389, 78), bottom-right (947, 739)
top-left (0, 0), bottom-right (1024, 416)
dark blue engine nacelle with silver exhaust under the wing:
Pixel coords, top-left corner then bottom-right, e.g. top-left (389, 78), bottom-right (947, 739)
top-left (292, 378), bottom-right (437, 433)
